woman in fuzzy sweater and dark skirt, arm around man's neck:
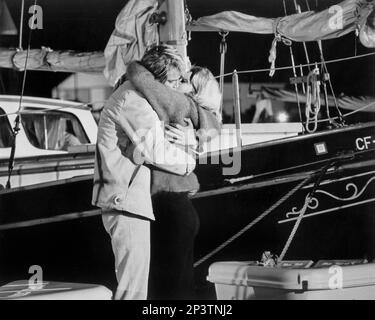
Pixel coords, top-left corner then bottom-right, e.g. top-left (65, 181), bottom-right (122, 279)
top-left (127, 62), bottom-right (221, 299)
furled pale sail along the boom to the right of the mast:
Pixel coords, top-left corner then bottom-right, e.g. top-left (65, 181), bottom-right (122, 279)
top-left (187, 0), bottom-right (375, 41)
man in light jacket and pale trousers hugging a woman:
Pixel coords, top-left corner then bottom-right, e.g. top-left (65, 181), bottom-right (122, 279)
top-left (92, 46), bottom-right (195, 299)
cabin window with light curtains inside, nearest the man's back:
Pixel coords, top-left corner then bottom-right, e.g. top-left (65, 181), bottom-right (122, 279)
top-left (21, 108), bottom-right (89, 150)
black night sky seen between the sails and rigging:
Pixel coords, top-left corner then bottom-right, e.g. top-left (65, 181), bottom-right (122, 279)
top-left (0, 0), bottom-right (375, 96)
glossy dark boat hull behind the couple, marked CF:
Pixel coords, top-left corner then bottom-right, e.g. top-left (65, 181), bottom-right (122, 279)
top-left (0, 123), bottom-right (375, 298)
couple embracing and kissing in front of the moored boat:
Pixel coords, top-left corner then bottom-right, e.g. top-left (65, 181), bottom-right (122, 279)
top-left (92, 45), bottom-right (221, 300)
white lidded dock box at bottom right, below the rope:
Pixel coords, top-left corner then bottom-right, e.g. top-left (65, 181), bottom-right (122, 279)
top-left (207, 262), bottom-right (375, 300)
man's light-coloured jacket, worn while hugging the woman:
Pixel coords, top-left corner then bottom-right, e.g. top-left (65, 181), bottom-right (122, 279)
top-left (92, 81), bottom-right (195, 220)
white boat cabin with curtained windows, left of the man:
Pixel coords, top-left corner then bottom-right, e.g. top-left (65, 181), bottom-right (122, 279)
top-left (0, 95), bottom-right (97, 187)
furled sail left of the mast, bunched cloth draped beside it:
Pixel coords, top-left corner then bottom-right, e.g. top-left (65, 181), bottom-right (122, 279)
top-left (0, 0), bottom-right (158, 80)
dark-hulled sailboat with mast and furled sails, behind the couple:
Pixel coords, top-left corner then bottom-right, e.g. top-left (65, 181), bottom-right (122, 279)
top-left (0, 0), bottom-right (375, 298)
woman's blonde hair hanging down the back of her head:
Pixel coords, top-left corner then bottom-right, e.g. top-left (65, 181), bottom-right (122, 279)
top-left (190, 66), bottom-right (222, 122)
